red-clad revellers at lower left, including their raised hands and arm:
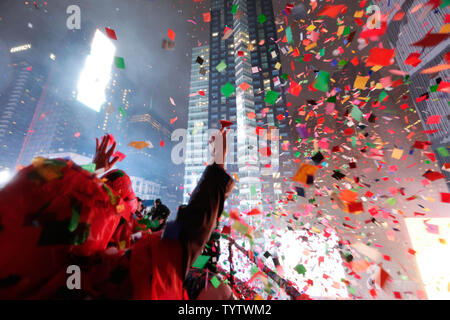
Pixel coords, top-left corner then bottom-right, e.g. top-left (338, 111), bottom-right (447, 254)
top-left (0, 129), bottom-right (234, 300)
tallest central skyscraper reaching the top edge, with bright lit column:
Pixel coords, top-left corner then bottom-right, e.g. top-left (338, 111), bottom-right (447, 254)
top-left (208, 0), bottom-right (286, 210)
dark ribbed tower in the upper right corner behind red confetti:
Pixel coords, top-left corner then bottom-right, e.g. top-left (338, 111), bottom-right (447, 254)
top-left (377, 0), bottom-right (450, 188)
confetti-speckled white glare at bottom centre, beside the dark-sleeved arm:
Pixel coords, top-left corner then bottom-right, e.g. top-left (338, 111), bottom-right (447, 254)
top-left (218, 229), bottom-right (349, 299)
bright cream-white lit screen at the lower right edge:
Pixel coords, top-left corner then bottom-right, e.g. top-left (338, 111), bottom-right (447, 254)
top-left (405, 218), bottom-right (450, 300)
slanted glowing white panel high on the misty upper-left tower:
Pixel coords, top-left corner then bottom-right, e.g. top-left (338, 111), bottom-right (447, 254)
top-left (77, 30), bottom-right (116, 112)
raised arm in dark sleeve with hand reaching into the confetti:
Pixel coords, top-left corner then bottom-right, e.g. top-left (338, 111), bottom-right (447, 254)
top-left (166, 132), bottom-right (234, 276)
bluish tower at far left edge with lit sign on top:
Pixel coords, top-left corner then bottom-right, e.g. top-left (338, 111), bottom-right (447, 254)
top-left (0, 44), bottom-right (50, 173)
